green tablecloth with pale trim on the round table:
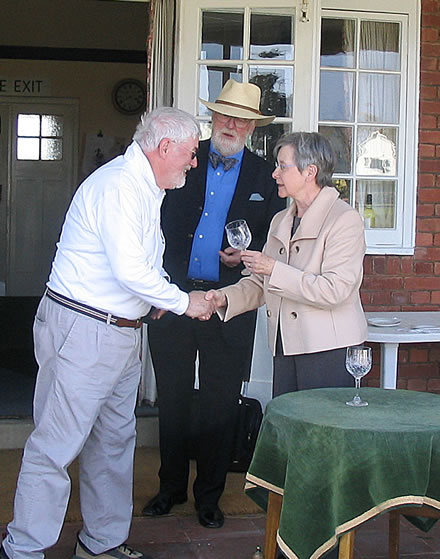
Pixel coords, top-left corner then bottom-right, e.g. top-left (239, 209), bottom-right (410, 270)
top-left (247, 388), bottom-right (440, 559)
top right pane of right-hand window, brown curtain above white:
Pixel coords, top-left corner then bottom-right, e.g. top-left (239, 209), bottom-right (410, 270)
top-left (359, 21), bottom-right (400, 70)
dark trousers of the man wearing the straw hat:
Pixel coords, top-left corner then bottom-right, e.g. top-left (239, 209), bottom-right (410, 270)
top-left (148, 315), bottom-right (253, 506)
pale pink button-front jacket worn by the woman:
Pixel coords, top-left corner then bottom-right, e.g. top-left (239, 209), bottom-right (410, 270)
top-left (222, 186), bottom-right (367, 355)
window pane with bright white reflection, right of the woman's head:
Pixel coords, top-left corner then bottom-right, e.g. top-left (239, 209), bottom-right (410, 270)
top-left (356, 126), bottom-right (397, 176)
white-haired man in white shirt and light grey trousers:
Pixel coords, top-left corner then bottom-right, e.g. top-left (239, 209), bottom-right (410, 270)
top-left (0, 108), bottom-right (213, 559)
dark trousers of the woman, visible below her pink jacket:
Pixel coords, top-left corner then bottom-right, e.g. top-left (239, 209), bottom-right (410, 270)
top-left (272, 336), bottom-right (354, 559)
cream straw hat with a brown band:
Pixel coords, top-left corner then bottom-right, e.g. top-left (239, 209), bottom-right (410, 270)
top-left (200, 80), bottom-right (275, 126)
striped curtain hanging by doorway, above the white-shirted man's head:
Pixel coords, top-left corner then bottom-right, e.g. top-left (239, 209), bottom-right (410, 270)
top-left (147, 0), bottom-right (176, 110)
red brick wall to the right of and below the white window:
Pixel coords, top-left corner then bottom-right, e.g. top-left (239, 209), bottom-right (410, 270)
top-left (361, 0), bottom-right (440, 393)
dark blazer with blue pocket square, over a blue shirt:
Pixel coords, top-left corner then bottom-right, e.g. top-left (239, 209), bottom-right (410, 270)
top-left (162, 140), bottom-right (286, 346)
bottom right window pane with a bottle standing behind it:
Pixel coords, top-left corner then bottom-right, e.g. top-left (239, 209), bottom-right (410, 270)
top-left (356, 180), bottom-right (397, 229)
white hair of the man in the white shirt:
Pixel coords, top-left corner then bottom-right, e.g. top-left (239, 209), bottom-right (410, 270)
top-left (133, 107), bottom-right (200, 153)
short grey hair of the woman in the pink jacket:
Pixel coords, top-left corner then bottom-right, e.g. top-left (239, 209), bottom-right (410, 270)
top-left (273, 132), bottom-right (335, 188)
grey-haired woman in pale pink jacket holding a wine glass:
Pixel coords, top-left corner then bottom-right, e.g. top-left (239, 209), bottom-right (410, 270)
top-left (206, 132), bottom-right (367, 396)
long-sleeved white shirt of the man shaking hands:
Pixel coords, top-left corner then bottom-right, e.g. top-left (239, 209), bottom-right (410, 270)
top-left (47, 142), bottom-right (189, 319)
